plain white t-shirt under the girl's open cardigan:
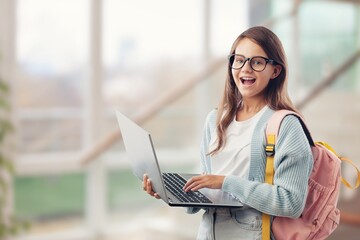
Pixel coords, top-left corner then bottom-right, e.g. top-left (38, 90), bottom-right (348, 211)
top-left (209, 106), bottom-right (268, 177)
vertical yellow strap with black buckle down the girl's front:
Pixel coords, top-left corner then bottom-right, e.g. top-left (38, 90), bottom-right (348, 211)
top-left (262, 134), bottom-right (275, 240)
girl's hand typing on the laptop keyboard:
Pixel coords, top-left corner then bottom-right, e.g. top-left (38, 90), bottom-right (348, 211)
top-left (183, 175), bottom-right (225, 192)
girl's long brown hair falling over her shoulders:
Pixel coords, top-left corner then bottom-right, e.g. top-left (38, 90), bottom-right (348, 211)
top-left (209, 26), bottom-right (298, 155)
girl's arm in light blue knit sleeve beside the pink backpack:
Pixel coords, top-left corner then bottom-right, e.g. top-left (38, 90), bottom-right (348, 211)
top-left (222, 116), bottom-right (313, 217)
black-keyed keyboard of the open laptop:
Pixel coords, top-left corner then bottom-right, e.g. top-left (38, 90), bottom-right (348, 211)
top-left (162, 173), bottom-right (211, 203)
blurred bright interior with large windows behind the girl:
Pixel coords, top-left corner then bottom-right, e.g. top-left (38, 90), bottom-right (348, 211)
top-left (0, 0), bottom-right (360, 240)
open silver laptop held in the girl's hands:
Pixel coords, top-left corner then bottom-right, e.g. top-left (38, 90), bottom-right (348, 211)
top-left (115, 110), bottom-right (243, 207)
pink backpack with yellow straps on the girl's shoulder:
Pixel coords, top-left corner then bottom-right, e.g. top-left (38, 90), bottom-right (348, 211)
top-left (262, 110), bottom-right (360, 240)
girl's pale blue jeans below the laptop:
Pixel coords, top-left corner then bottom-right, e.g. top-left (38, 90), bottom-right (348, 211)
top-left (197, 207), bottom-right (262, 240)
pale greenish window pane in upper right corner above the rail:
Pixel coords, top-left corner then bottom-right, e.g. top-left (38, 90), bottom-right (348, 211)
top-left (300, 2), bottom-right (356, 90)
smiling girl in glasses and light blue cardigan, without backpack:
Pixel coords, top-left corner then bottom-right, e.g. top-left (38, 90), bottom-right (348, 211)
top-left (144, 26), bottom-right (313, 240)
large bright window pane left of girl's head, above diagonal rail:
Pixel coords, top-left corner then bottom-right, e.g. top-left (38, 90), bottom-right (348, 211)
top-left (103, 0), bottom-right (203, 115)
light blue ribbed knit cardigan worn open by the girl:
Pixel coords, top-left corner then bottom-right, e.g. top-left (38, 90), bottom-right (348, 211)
top-left (188, 108), bottom-right (313, 218)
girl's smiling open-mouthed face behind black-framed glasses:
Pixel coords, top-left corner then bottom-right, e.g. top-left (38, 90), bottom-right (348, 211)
top-left (231, 38), bottom-right (281, 101)
